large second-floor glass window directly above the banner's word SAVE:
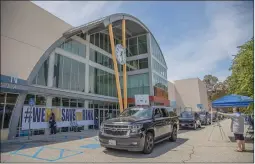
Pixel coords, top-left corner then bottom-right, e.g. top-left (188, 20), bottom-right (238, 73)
top-left (53, 54), bottom-right (85, 92)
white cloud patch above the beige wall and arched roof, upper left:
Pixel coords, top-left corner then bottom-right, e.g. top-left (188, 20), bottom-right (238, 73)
top-left (33, 1), bottom-right (122, 26)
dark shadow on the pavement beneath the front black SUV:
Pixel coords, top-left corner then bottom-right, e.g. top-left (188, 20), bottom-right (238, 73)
top-left (103, 138), bottom-right (188, 158)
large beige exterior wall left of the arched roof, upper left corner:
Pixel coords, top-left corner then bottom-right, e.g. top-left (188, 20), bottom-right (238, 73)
top-left (1, 1), bottom-right (72, 80)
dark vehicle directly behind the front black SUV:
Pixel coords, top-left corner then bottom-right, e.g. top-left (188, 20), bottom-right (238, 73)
top-left (179, 111), bottom-right (202, 130)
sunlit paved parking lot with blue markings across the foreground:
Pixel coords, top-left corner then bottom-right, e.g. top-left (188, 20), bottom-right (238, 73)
top-left (1, 120), bottom-right (254, 163)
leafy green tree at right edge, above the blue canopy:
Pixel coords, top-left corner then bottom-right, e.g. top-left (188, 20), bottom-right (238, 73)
top-left (227, 38), bottom-right (254, 112)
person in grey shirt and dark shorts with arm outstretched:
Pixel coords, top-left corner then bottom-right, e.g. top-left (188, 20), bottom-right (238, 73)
top-left (218, 108), bottom-right (245, 152)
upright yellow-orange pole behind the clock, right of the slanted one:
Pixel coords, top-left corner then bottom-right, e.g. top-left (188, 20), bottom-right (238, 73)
top-left (121, 19), bottom-right (127, 112)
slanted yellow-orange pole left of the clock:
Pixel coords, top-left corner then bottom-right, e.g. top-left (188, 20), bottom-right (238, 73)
top-left (108, 24), bottom-right (123, 112)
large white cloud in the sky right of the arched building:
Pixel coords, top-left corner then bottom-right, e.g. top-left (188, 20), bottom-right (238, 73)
top-left (163, 2), bottom-right (253, 80)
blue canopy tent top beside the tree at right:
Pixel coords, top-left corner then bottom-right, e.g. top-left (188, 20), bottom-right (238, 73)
top-left (212, 94), bottom-right (253, 108)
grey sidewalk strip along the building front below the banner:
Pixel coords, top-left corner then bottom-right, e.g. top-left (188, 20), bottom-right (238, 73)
top-left (1, 129), bottom-right (98, 144)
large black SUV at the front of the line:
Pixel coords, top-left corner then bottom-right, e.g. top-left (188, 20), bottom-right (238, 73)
top-left (99, 106), bottom-right (179, 154)
